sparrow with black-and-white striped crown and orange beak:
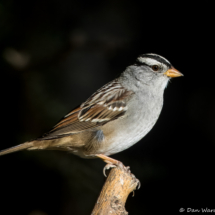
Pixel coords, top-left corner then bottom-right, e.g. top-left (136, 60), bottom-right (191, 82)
top-left (0, 53), bottom-right (183, 176)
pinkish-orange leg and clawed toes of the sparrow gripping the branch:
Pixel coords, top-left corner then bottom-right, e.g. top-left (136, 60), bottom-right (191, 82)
top-left (96, 154), bottom-right (141, 189)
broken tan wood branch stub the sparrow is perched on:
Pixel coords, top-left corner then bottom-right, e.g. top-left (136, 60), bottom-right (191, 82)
top-left (91, 167), bottom-right (139, 215)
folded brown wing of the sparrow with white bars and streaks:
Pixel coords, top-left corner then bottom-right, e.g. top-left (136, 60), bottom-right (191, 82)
top-left (39, 80), bottom-right (133, 139)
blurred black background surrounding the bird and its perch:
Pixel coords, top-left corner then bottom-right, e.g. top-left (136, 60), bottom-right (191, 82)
top-left (0, 0), bottom-right (215, 215)
